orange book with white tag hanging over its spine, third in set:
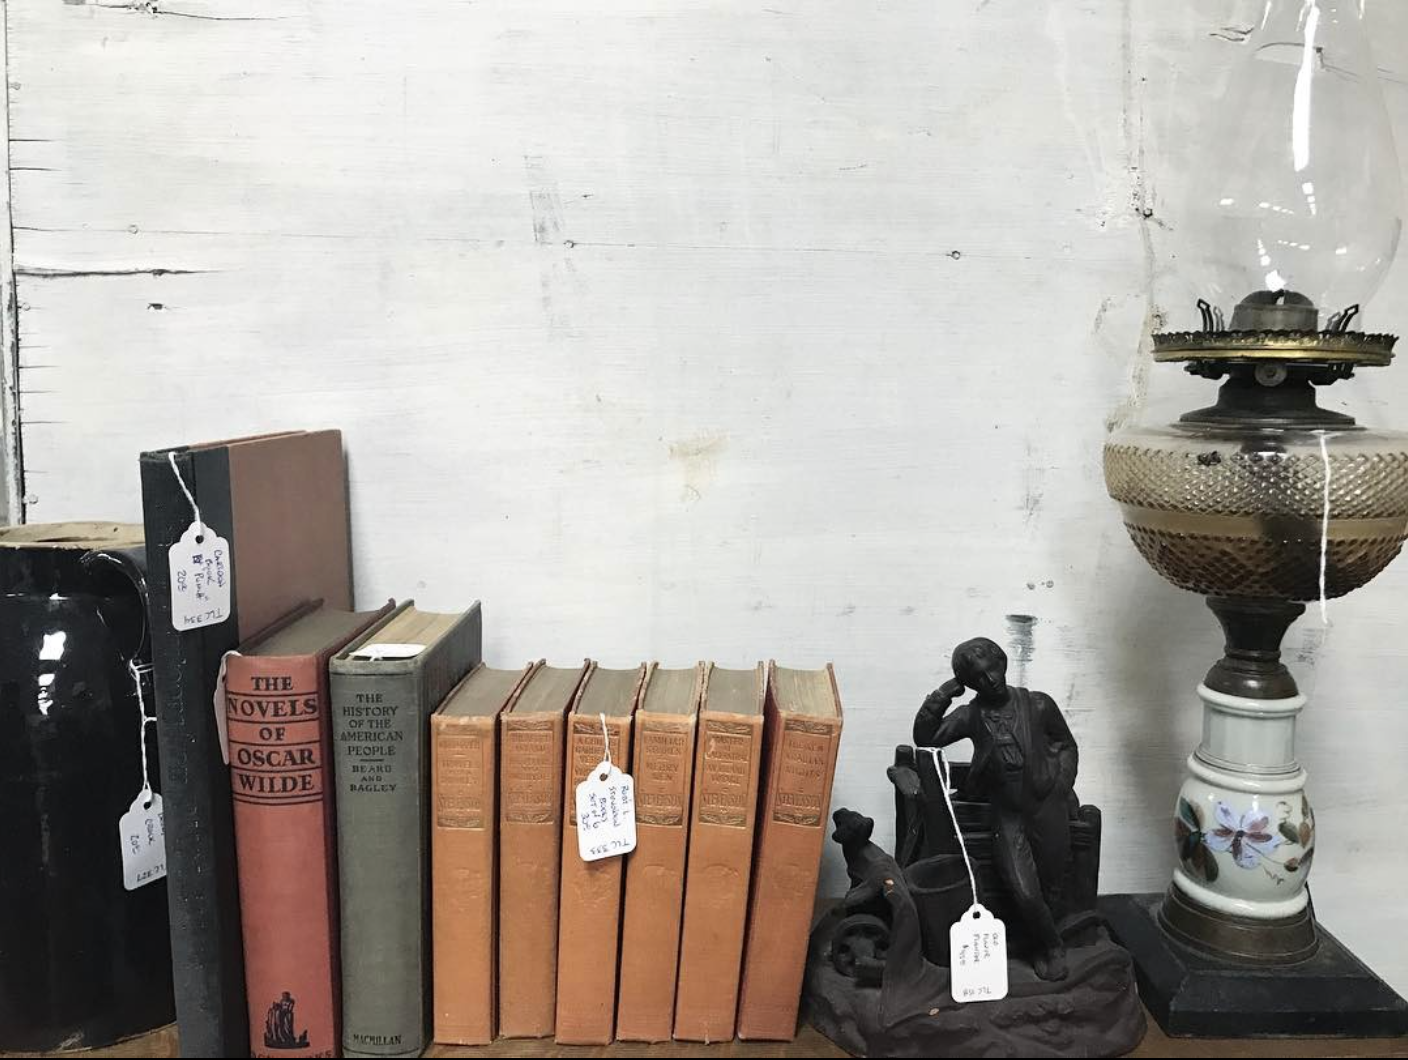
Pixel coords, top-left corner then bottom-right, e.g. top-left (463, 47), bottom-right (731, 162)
top-left (556, 664), bottom-right (645, 1046)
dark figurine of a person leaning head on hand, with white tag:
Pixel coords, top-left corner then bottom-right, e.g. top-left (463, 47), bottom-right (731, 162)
top-left (804, 638), bottom-right (1145, 1057)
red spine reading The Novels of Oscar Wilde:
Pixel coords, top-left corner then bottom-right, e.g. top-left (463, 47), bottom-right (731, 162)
top-left (225, 656), bottom-right (341, 1057)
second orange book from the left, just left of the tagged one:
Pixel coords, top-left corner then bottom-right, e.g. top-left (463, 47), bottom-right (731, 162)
top-left (498, 663), bottom-right (587, 1037)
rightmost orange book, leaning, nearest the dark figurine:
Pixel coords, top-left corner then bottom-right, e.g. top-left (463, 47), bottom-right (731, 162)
top-left (738, 663), bottom-right (841, 1042)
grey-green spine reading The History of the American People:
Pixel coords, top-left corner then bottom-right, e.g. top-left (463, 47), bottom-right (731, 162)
top-left (331, 667), bottom-right (429, 1056)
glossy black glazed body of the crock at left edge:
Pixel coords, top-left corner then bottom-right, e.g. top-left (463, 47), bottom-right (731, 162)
top-left (0, 546), bottom-right (173, 1052)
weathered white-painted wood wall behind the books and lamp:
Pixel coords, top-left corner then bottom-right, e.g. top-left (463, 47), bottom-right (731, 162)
top-left (6, 0), bottom-right (1408, 991)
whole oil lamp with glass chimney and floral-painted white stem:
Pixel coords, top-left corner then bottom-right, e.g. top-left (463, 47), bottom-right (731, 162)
top-left (1104, 0), bottom-right (1408, 1036)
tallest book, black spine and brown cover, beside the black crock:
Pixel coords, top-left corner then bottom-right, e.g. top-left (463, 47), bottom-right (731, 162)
top-left (141, 431), bottom-right (352, 1057)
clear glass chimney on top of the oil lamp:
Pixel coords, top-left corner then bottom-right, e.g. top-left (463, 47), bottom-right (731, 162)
top-left (1180, 0), bottom-right (1402, 331)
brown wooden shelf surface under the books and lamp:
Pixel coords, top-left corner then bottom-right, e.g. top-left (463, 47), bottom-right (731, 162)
top-left (0, 1019), bottom-right (1408, 1057)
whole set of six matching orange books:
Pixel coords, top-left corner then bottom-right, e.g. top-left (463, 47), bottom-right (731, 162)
top-left (429, 663), bottom-right (841, 1045)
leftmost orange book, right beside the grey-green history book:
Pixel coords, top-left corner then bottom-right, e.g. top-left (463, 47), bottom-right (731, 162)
top-left (431, 664), bottom-right (534, 1046)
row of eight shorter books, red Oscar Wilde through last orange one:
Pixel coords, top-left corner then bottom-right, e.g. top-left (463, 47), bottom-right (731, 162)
top-left (222, 602), bottom-right (841, 1056)
